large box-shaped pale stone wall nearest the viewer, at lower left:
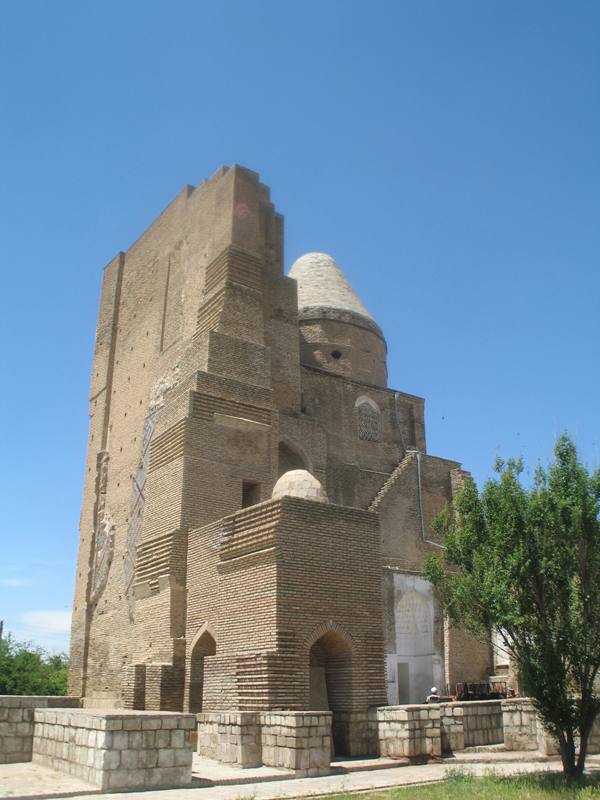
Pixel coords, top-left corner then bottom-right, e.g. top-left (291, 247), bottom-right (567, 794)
top-left (33, 709), bottom-right (195, 789)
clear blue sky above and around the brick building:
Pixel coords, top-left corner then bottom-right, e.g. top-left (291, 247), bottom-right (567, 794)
top-left (0, 0), bottom-right (600, 650)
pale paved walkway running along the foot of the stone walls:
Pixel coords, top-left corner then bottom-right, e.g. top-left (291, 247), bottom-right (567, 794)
top-left (0, 751), bottom-right (600, 800)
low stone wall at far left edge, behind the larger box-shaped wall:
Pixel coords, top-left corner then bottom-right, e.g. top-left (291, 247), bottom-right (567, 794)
top-left (0, 695), bottom-right (79, 764)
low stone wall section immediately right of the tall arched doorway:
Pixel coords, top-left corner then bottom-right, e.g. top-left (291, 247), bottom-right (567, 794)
top-left (377, 703), bottom-right (442, 758)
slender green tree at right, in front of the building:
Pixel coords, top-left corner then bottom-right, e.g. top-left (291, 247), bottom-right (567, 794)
top-left (426, 435), bottom-right (600, 777)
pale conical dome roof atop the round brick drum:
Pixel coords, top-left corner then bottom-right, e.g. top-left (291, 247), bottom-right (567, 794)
top-left (289, 253), bottom-right (374, 322)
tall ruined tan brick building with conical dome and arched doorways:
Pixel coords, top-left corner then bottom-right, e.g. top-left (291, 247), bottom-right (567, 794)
top-left (70, 166), bottom-right (489, 753)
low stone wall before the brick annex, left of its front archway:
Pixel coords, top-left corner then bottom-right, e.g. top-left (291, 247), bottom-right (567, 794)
top-left (196, 711), bottom-right (331, 775)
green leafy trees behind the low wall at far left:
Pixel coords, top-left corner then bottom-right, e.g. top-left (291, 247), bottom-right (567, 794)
top-left (0, 635), bottom-right (67, 695)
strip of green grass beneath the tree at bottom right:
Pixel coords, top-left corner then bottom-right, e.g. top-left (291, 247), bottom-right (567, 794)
top-left (332, 769), bottom-right (600, 800)
